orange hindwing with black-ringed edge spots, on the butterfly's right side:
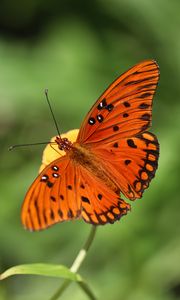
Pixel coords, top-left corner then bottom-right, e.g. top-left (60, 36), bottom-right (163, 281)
top-left (93, 132), bottom-right (159, 200)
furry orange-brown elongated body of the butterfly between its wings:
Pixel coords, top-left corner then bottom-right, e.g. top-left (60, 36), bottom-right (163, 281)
top-left (68, 142), bottom-right (119, 194)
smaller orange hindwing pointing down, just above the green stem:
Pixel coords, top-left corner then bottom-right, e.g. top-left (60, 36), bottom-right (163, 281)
top-left (77, 166), bottom-right (130, 225)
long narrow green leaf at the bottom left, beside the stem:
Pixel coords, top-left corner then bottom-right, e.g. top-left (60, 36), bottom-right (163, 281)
top-left (0, 263), bottom-right (82, 282)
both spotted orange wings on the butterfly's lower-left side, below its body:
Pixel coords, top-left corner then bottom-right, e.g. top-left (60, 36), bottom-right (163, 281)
top-left (21, 158), bottom-right (130, 231)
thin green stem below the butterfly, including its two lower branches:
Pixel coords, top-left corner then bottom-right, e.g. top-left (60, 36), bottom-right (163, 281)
top-left (50, 225), bottom-right (96, 300)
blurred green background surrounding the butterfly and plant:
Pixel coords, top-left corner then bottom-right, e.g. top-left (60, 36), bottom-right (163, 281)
top-left (0, 0), bottom-right (180, 300)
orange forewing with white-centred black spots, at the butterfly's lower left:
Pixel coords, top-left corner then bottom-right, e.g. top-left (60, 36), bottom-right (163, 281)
top-left (21, 156), bottom-right (80, 230)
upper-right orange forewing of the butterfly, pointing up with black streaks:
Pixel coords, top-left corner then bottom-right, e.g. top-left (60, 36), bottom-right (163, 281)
top-left (77, 60), bottom-right (159, 144)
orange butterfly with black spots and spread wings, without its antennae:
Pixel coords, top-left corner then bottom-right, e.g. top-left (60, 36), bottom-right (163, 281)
top-left (21, 60), bottom-right (159, 231)
